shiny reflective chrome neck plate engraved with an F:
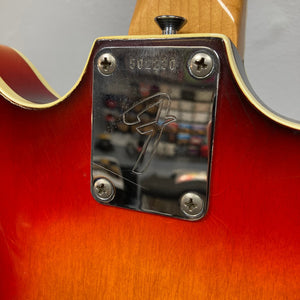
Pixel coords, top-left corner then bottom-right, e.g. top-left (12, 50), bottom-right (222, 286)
top-left (91, 46), bottom-right (219, 220)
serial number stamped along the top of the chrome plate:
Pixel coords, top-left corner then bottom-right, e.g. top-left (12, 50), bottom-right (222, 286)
top-left (129, 57), bottom-right (176, 71)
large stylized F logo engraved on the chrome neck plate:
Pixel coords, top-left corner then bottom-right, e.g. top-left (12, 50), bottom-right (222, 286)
top-left (123, 93), bottom-right (176, 174)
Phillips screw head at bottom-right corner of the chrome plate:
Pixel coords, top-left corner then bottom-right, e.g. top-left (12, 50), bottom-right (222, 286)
top-left (180, 192), bottom-right (204, 218)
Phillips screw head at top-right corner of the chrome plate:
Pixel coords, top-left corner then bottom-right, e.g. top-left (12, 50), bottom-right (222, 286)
top-left (188, 52), bottom-right (213, 79)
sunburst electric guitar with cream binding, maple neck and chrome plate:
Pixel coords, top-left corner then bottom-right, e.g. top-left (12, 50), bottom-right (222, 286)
top-left (0, 0), bottom-right (300, 299)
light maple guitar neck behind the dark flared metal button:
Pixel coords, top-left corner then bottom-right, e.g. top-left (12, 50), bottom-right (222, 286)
top-left (129, 0), bottom-right (246, 53)
